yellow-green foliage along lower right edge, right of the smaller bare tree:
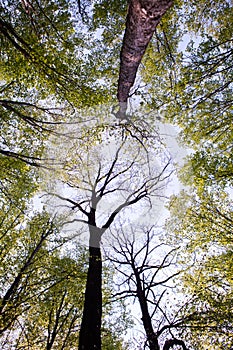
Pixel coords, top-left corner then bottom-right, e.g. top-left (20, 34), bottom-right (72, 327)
top-left (168, 192), bottom-right (232, 349)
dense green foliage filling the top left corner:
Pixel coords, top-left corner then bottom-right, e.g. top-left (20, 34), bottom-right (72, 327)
top-left (1, 0), bottom-right (114, 107)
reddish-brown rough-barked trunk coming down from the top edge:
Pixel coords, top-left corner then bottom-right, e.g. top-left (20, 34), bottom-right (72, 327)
top-left (117, 0), bottom-right (173, 118)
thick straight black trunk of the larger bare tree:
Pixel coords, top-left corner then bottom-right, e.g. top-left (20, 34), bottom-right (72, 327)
top-left (78, 226), bottom-right (102, 350)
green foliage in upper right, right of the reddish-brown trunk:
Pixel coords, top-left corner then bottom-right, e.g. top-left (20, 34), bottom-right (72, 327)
top-left (137, 0), bottom-right (233, 188)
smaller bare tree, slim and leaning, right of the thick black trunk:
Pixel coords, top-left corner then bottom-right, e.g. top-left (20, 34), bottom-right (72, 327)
top-left (108, 226), bottom-right (187, 350)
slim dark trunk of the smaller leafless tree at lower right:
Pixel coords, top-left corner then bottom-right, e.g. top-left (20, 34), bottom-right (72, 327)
top-left (134, 268), bottom-right (159, 350)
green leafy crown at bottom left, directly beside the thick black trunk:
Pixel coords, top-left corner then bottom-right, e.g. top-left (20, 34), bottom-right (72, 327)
top-left (8, 256), bottom-right (85, 349)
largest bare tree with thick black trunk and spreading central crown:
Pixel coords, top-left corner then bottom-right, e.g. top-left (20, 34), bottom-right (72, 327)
top-left (46, 133), bottom-right (170, 350)
